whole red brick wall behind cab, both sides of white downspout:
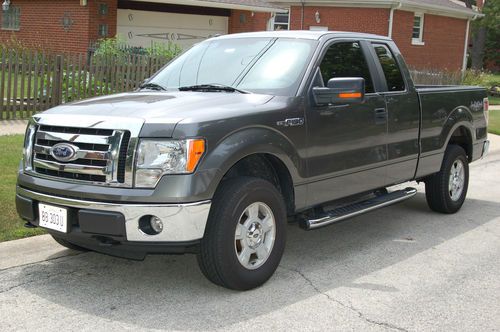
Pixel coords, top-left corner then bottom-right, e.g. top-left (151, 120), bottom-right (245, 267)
top-left (290, 6), bottom-right (467, 70)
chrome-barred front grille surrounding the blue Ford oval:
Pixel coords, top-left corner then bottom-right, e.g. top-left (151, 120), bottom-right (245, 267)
top-left (33, 125), bottom-right (130, 185)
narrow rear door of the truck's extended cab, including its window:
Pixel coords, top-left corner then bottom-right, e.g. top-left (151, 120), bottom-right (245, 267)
top-left (370, 41), bottom-right (420, 185)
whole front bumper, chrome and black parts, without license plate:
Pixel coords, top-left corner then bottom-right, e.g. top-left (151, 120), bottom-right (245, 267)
top-left (16, 186), bottom-right (211, 255)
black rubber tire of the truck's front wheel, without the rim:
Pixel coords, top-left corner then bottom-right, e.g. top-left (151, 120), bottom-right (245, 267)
top-left (197, 177), bottom-right (286, 290)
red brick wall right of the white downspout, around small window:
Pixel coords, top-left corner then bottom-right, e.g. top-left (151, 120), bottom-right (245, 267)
top-left (392, 10), bottom-right (467, 71)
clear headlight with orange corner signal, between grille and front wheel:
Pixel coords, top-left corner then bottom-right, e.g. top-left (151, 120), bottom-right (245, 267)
top-left (135, 139), bottom-right (205, 188)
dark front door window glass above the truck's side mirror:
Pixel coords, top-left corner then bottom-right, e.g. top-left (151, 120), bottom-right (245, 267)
top-left (320, 42), bottom-right (374, 93)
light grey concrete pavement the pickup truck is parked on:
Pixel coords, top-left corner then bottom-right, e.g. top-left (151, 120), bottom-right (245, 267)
top-left (0, 136), bottom-right (500, 331)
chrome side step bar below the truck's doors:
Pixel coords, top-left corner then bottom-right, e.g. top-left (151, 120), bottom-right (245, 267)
top-left (300, 188), bottom-right (417, 230)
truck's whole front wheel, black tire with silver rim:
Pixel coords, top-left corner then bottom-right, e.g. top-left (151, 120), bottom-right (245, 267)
top-left (198, 177), bottom-right (286, 290)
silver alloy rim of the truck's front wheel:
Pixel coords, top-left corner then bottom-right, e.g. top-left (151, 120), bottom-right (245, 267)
top-left (234, 202), bottom-right (276, 270)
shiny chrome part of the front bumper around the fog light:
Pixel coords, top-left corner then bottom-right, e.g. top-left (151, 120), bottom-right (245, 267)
top-left (17, 187), bottom-right (211, 242)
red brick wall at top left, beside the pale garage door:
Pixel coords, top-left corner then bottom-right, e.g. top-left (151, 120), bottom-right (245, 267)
top-left (0, 0), bottom-right (117, 52)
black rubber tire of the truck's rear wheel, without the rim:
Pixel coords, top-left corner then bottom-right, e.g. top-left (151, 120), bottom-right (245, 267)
top-left (425, 145), bottom-right (469, 214)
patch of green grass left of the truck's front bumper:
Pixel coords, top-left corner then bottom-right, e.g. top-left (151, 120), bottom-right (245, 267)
top-left (0, 135), bottom-right (44, 242)
